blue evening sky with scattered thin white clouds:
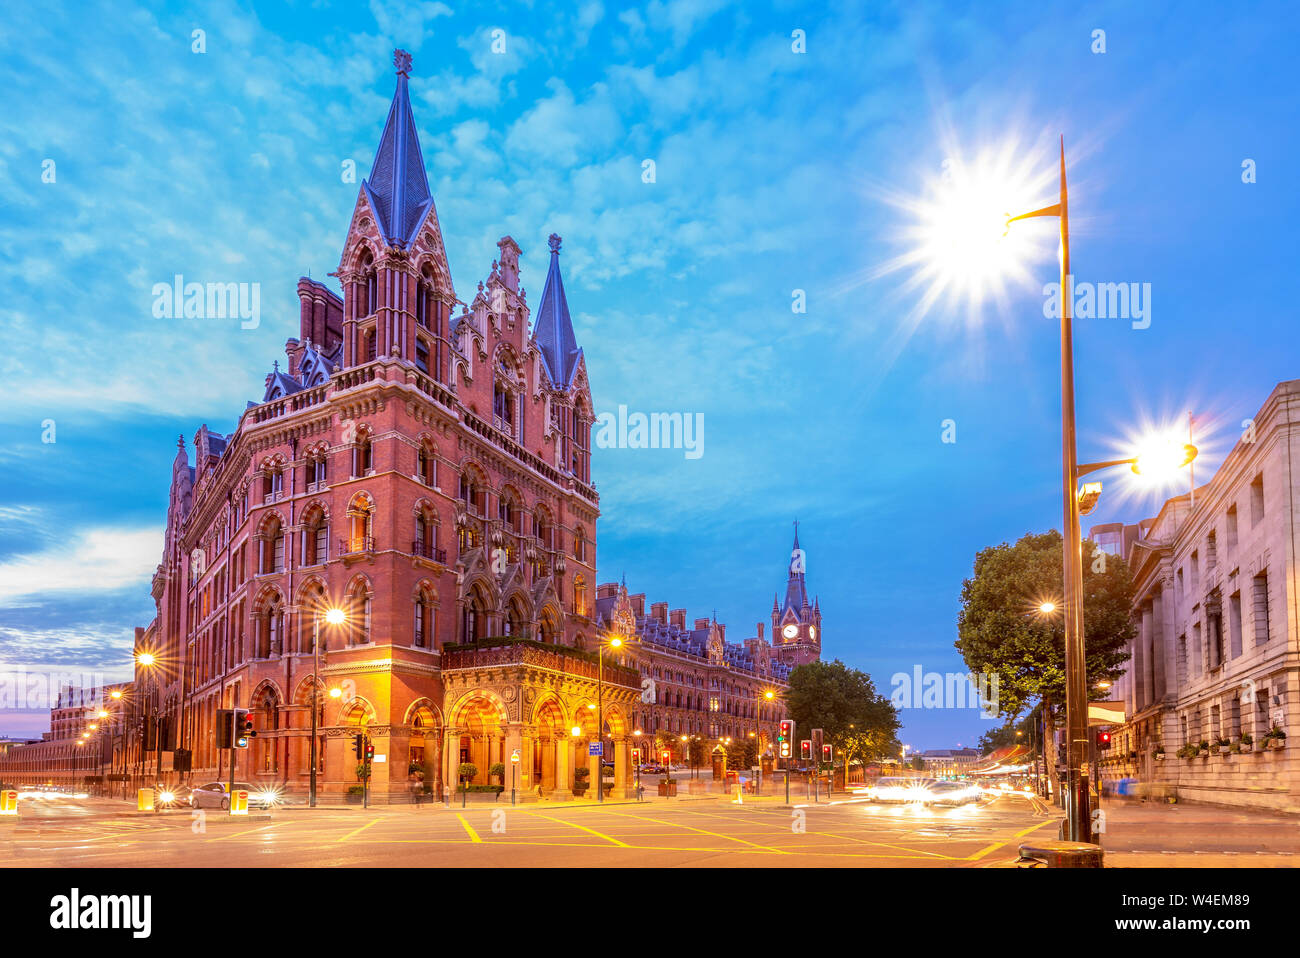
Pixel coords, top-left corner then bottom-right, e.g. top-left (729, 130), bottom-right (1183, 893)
top-left (0, 0), bottom-right (1300, 747)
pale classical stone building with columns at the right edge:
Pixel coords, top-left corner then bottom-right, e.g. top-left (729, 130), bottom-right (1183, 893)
top-left (1093, 380), bottom-right (1300, 811)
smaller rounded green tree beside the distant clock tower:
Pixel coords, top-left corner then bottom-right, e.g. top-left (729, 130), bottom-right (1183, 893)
top-left (785, 659), bottom-right (901, 762)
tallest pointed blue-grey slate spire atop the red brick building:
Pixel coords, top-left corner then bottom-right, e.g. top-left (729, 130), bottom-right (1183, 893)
top-left (361, 49), bottom-right (433, 248)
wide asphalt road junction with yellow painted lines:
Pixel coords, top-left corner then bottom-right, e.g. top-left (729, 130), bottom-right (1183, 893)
top-left (0, 797), bottom-right (1056, 868)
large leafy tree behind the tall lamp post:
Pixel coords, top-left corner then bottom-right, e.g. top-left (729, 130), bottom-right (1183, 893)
top-left (956, 530), bottom-right (1135, 718)
